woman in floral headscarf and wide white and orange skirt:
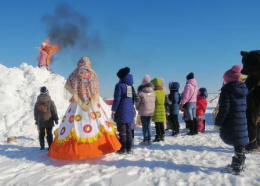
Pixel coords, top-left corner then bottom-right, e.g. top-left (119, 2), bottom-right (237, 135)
top-left (48, 57), bottom-right (121, 160)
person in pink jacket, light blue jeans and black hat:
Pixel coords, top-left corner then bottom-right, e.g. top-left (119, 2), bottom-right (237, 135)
top-left (180, 72), bottom-right (198, 135)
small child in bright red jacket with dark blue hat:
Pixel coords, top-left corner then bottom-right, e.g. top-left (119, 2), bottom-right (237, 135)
top-left (196, 88), bottom-right (208, 132)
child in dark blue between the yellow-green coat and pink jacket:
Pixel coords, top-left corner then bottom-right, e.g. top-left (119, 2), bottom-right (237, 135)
top-left (169, 82), bottom-right (181, 136)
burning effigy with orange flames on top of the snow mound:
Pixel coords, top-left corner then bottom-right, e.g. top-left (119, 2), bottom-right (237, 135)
top-left (37, 38), bottom-right (60, 70)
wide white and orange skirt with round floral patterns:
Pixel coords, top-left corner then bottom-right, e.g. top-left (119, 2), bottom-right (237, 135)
top-left (48, 103), bottom-right (121, 160)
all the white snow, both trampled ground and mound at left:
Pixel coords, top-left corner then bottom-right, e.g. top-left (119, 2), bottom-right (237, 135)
top-left (0, 63), bottom-right (260, 186)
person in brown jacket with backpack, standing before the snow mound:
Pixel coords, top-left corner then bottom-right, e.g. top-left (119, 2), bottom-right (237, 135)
top-left (34, 87), bottom-right (59, 150)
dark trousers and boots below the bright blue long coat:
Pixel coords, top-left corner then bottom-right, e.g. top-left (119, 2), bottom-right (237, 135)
top-left (117, 123), bottom-right (133, 150)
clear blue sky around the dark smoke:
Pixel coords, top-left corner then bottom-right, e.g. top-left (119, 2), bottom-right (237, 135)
top-left (0, 0), bottom-right (260, 97)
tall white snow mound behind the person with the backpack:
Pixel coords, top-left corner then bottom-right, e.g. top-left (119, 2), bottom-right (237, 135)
top-left (0, 63), bottom-right (110, 137)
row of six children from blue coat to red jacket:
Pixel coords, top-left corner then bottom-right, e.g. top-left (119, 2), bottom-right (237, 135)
top-left (112, 67), bottom-right (208, 154)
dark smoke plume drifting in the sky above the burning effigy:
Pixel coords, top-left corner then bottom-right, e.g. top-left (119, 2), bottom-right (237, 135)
top-left (42, 4), bottom-right (103, 50)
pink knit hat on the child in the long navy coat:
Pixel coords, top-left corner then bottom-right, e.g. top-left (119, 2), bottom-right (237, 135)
top-left (223, 65), bottom-right (242, 83)
